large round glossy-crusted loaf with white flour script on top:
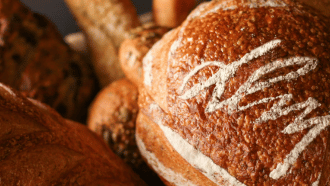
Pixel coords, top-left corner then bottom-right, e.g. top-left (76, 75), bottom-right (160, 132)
top-left (136, 0), bottom-right (330, 186)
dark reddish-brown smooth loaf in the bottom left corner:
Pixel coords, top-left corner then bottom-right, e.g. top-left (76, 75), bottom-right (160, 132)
top-left (0, 84), bottom-right (145, 186)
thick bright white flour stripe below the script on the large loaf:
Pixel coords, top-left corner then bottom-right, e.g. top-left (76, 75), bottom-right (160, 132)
top-left (149, 103), bottom-right (246, 186)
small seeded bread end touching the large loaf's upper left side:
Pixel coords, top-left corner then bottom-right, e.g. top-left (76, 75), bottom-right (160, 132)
top-left (119, 23), bottom-right (170, 86)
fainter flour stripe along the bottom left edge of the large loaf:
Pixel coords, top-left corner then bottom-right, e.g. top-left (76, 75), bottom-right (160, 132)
top-left (136, 134), bottom-right (196, 186)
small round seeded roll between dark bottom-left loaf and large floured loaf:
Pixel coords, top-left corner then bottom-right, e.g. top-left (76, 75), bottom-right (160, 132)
top-left (87, 78), bottom-right (162, 186)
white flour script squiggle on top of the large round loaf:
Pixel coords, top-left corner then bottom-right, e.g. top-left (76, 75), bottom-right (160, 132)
top-left (179, 40), bottom-right (330, 179)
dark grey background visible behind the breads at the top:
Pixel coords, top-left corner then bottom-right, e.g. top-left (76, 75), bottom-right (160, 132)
top-left (21, 0), bottom-right (152, 36)
